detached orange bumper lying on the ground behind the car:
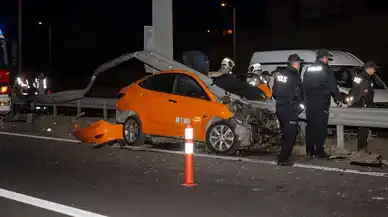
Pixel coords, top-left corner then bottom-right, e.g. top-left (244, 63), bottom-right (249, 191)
top-left (73, 120), bottom-right (123, 144)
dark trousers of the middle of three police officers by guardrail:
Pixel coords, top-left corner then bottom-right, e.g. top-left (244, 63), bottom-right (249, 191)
top-left (306, 94), bottom-right (331, 155)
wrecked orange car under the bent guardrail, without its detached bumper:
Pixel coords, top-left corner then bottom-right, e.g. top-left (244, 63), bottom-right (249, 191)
top-left (116, 70), bottom-right (242, 152)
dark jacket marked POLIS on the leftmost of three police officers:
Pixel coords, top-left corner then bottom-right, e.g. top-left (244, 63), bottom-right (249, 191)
top-left (272, 66), bottom-right (303, 104)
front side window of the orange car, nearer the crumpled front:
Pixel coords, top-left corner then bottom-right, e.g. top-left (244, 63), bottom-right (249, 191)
top-left (175, 75), bottom-right (210, 100)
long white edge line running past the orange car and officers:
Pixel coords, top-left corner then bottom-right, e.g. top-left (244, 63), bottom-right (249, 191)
top-left (0, 131), bottom-right (388, 178)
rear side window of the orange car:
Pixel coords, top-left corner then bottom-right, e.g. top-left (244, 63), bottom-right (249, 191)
top-left (139, 73), bottom-right (176, 93)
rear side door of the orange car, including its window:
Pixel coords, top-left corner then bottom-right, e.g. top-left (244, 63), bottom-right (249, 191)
top-left (138, 73), bottom-right (176, 136)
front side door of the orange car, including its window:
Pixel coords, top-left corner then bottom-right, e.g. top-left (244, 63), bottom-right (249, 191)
top-left (169, 74), bottom-right (215, 140)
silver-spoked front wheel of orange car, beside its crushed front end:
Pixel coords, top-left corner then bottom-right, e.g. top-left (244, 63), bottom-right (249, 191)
top-left (206, 120), bottom-right (240, 155)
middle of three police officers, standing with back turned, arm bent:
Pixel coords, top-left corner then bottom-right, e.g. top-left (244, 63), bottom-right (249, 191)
top-left (303, 50), bottom-right (342, 158)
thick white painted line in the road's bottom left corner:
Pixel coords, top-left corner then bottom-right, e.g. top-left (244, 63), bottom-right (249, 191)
top-left (0, 188), bottom-right (107, 217)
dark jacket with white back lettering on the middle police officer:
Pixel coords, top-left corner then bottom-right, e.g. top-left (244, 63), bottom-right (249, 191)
top-left (303, 60), bottom-right (341, 101)
